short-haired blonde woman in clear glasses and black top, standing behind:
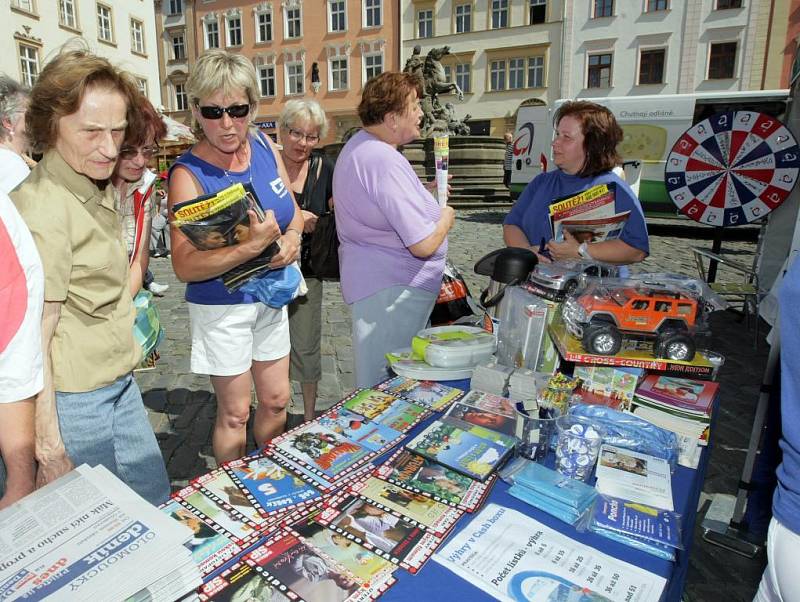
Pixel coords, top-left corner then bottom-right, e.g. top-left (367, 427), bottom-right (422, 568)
top-left (278, 100), bottom-right (333, 420)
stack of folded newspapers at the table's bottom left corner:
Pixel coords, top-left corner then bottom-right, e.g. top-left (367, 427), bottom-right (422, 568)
top-left (0, 464), bottom-right (201, 602)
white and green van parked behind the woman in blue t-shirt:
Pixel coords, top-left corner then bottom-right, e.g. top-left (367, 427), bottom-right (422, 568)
top-left (511, 90), bottom-right (789, 214)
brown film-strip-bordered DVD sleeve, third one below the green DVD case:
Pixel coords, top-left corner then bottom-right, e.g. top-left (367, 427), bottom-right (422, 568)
top-left (317, 496), bottom-right (442, 573)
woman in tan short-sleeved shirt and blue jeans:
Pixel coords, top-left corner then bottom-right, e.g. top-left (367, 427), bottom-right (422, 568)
top-left (10, 50), bottom-right (169, 504)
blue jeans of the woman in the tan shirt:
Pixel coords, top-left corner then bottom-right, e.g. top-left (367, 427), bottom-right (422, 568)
top-left (56, 374), bottom-right (169, 505)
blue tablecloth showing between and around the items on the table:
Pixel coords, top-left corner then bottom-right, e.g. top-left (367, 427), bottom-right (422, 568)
top-left (381, 381), bottom-right (710, 602)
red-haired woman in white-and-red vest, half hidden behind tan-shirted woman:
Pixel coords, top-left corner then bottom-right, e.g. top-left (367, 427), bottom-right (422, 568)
top-left (111, 96), bottom-right (167, 297)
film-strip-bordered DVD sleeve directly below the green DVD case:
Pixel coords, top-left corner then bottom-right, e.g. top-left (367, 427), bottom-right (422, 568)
top-left (375, 449), bottom-right (496, 512)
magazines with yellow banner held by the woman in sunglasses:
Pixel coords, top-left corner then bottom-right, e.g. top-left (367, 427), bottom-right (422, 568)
top-left (172, 183), bottom-right (279, 291)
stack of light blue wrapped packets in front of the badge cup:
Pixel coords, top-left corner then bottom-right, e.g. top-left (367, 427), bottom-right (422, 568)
top-left (504, 461), bottom-right (597, 525)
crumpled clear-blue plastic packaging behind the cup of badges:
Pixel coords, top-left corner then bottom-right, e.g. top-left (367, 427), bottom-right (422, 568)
top-left (569, 403), bottom-right (678, 472)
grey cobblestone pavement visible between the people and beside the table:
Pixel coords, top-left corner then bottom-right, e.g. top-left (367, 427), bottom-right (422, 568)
top-left (142, 209), bottom-right (767, 602)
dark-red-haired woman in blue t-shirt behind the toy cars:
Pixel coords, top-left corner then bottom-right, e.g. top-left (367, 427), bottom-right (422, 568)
top-left (503, 100), bottom-right (650, 265)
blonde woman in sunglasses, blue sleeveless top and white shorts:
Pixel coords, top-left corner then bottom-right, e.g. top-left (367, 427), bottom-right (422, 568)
top-left (169, 50), bottom-right (303, 463)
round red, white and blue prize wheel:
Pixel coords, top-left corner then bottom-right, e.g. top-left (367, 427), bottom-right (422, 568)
top-left (664, 111), bottom-right (800, 226)
